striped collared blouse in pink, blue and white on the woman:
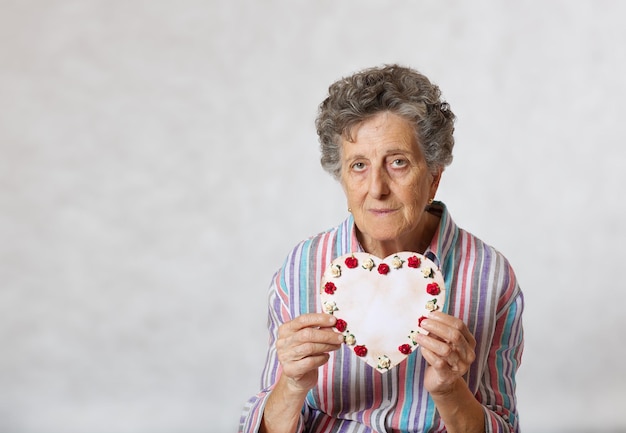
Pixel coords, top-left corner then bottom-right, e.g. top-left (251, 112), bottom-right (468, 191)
top-left (239, 202), bottom-right (524, 433)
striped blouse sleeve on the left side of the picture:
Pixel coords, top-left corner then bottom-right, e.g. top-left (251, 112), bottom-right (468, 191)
top-left (239, 270), bottom-right (304, 433)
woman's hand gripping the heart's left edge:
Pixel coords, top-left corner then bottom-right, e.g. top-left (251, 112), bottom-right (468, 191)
top-left (276, 313), bottom-right (343, 393)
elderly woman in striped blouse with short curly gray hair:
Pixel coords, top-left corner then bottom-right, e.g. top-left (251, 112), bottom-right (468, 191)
top-left (240, 65), bottom-right (523, 433)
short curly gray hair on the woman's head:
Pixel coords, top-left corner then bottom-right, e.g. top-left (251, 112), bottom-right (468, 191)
top-left (315, 65), bottom-right (455, 179)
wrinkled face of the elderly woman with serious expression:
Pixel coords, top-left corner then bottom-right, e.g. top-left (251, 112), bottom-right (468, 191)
top-left (341, 112), bottom-right (441, 254)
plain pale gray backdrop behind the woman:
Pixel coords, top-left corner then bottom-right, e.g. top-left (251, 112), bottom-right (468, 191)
top-left (0, 0), bottom-right (626, 433)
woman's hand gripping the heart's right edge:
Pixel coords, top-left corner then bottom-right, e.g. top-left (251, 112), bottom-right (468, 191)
top-left (418, 311), bottom-right (476, 394)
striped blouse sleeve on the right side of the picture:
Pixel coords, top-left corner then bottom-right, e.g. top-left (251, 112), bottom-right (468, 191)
top-left (477, 269), bottom-right (524, 433)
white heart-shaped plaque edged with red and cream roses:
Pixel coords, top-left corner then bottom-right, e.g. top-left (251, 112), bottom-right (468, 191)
top-left (320, 251), bottom-right (446, 372)
